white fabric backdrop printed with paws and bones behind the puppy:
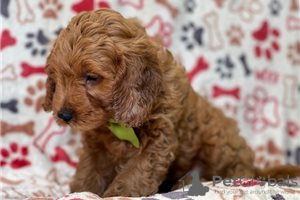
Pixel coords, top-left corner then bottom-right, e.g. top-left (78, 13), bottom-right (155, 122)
top-left (0, 0), bottom-right (300, 199)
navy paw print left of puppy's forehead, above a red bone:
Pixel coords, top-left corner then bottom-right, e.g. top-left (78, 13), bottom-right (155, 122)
top-left (25, 29), bottom-right (50, 56)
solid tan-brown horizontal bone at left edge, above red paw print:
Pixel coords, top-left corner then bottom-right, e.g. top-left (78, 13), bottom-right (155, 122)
top-left (0, 121), bottom-right (34, 136)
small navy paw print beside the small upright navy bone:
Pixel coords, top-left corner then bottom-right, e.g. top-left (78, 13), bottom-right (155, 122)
top-left (216, 55), bottom-right (234, 78)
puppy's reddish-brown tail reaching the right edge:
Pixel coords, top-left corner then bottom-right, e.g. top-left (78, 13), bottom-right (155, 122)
top-left (255, 165), bottom-right (300, 179)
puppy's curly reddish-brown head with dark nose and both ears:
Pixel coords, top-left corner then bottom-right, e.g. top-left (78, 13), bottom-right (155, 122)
top-left (44, 9), bottom-right (161, 130)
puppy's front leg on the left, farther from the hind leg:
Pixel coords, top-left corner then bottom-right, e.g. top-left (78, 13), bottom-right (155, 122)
top-left (70, 151), bottom-right (114, 196)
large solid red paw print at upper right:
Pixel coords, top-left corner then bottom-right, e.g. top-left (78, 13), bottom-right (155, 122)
top-left (252, 21), bottom-right (280, 60)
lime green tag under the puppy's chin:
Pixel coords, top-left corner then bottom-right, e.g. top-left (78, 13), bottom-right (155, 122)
top-left (108, 120), bottom-right (140, 148)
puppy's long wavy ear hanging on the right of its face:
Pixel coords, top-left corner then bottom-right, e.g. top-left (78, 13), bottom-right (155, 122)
top-left (113, 37), bottom-right (161, 127)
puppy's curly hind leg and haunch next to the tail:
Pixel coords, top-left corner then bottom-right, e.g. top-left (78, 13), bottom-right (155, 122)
top-left (199, 106), bottom-right (255, 180)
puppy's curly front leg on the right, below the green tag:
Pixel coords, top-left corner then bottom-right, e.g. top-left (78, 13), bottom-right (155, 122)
top-left (103, 122), bottom-right (178, 197)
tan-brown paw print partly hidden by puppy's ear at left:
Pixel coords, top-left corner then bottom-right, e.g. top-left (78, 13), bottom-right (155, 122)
top-left (24, 80), bottom-right (45, 112)
